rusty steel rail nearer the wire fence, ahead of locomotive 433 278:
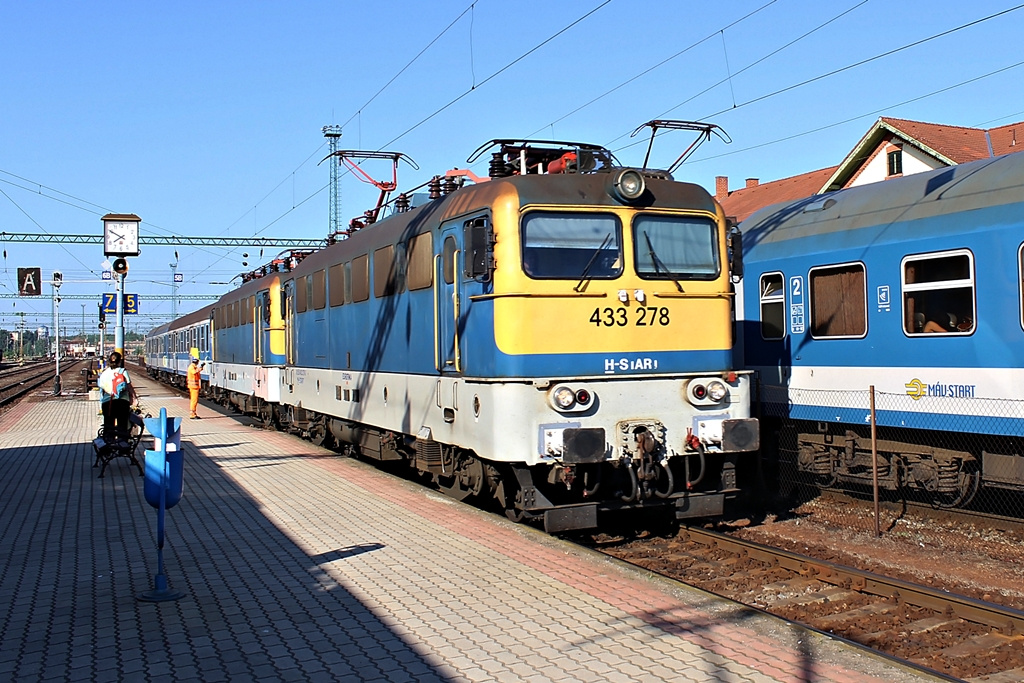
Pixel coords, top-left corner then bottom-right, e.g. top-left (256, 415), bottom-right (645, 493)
top-left (681, 528), bottom-right (1024, 635)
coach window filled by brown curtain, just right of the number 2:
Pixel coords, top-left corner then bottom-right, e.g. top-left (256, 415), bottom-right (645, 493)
top-left (807, 263), bottom-right (867, 338)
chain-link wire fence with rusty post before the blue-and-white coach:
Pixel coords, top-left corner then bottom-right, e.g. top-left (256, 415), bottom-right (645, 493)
top-left (759, 382), bottom-right (1024, 528)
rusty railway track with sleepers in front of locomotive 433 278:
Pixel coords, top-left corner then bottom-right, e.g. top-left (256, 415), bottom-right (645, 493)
top-left (598, 528), bottom-right (1024, 681)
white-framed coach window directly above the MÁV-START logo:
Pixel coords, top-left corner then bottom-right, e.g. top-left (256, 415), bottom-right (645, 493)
top-left (902, 250), bottom-right (975, 336)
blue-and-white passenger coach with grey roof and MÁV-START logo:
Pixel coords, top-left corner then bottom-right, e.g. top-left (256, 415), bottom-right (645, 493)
top-left (740, 154), bottom-right (1024, 507)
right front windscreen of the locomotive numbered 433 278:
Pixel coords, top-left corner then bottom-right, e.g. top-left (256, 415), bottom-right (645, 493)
top-left (633, 214), bottom-right (719, 280)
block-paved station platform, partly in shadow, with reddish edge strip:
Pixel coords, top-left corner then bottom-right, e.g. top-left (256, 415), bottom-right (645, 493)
top-left (0, 379), bottom-right (942, 682)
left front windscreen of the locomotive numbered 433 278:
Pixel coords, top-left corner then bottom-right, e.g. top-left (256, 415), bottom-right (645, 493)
top-left (522, 211), bottom-right (623, 280)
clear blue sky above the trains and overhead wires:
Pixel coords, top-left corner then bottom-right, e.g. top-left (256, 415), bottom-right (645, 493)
top-left (0, 0), bottom-right (1024, 333)
